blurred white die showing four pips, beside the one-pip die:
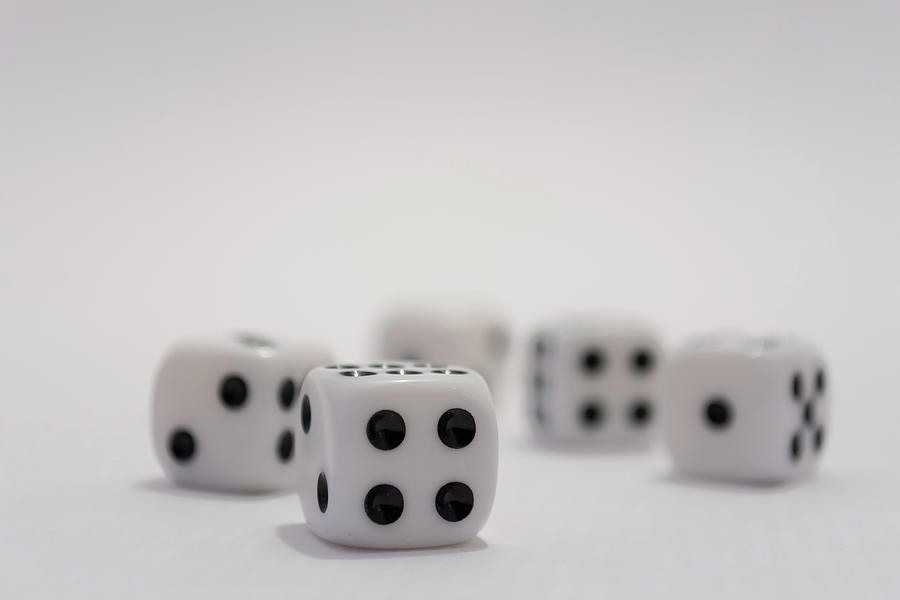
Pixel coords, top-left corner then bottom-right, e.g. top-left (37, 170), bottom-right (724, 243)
top-left (526, 317), bottom-right (663, 446)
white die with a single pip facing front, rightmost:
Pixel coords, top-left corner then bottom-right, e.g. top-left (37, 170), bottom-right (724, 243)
top-left (665, 334), bottom-right (830, 483)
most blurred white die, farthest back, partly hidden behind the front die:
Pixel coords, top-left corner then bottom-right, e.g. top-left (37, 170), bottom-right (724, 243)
top-left (377, 303), bottom-right (510, 389)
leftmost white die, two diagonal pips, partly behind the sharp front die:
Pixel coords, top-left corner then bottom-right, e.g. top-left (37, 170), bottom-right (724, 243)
top-left (153, 334), bottom-right (330, 492)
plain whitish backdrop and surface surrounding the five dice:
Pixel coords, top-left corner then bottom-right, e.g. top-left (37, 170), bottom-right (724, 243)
top-left (0, 0), bottom-right (900, 599)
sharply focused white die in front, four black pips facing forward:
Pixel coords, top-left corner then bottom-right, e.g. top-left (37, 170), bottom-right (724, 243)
top-left (298, 363), bottom-right (497, 548)
